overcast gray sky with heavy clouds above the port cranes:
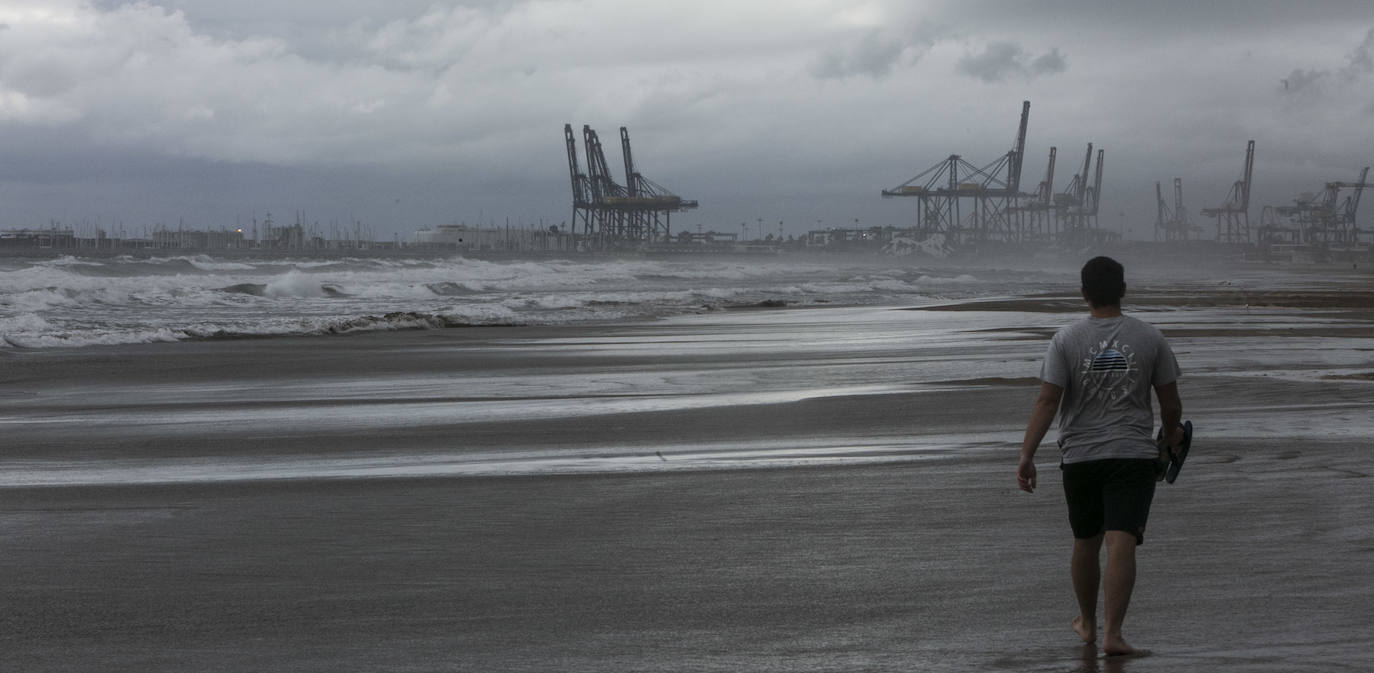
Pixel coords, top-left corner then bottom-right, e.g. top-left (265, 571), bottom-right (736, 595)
top-left (0, 0), bottom-right (1374, 238)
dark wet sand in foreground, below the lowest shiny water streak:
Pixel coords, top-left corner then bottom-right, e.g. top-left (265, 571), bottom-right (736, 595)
top-left (0, 434), bottom-right (1374, 672)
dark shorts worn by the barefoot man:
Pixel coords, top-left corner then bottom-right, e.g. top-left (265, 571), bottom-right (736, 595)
top-left (1059, 459), bottom-right (1157, 544)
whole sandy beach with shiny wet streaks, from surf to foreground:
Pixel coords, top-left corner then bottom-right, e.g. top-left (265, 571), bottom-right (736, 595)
top-left (0, 270), bottom-right (1374, 672)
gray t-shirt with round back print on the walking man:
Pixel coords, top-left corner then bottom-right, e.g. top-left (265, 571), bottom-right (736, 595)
top-left (1040, 316), bottom-right (1179, 464)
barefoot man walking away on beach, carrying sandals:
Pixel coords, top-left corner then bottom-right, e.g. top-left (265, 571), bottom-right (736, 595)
top-left (1017, 257), bottom-right (1183, 655)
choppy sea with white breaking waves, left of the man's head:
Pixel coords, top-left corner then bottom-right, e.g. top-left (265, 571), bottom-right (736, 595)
top-left (0, 254), bottom-right (1073, 349)
